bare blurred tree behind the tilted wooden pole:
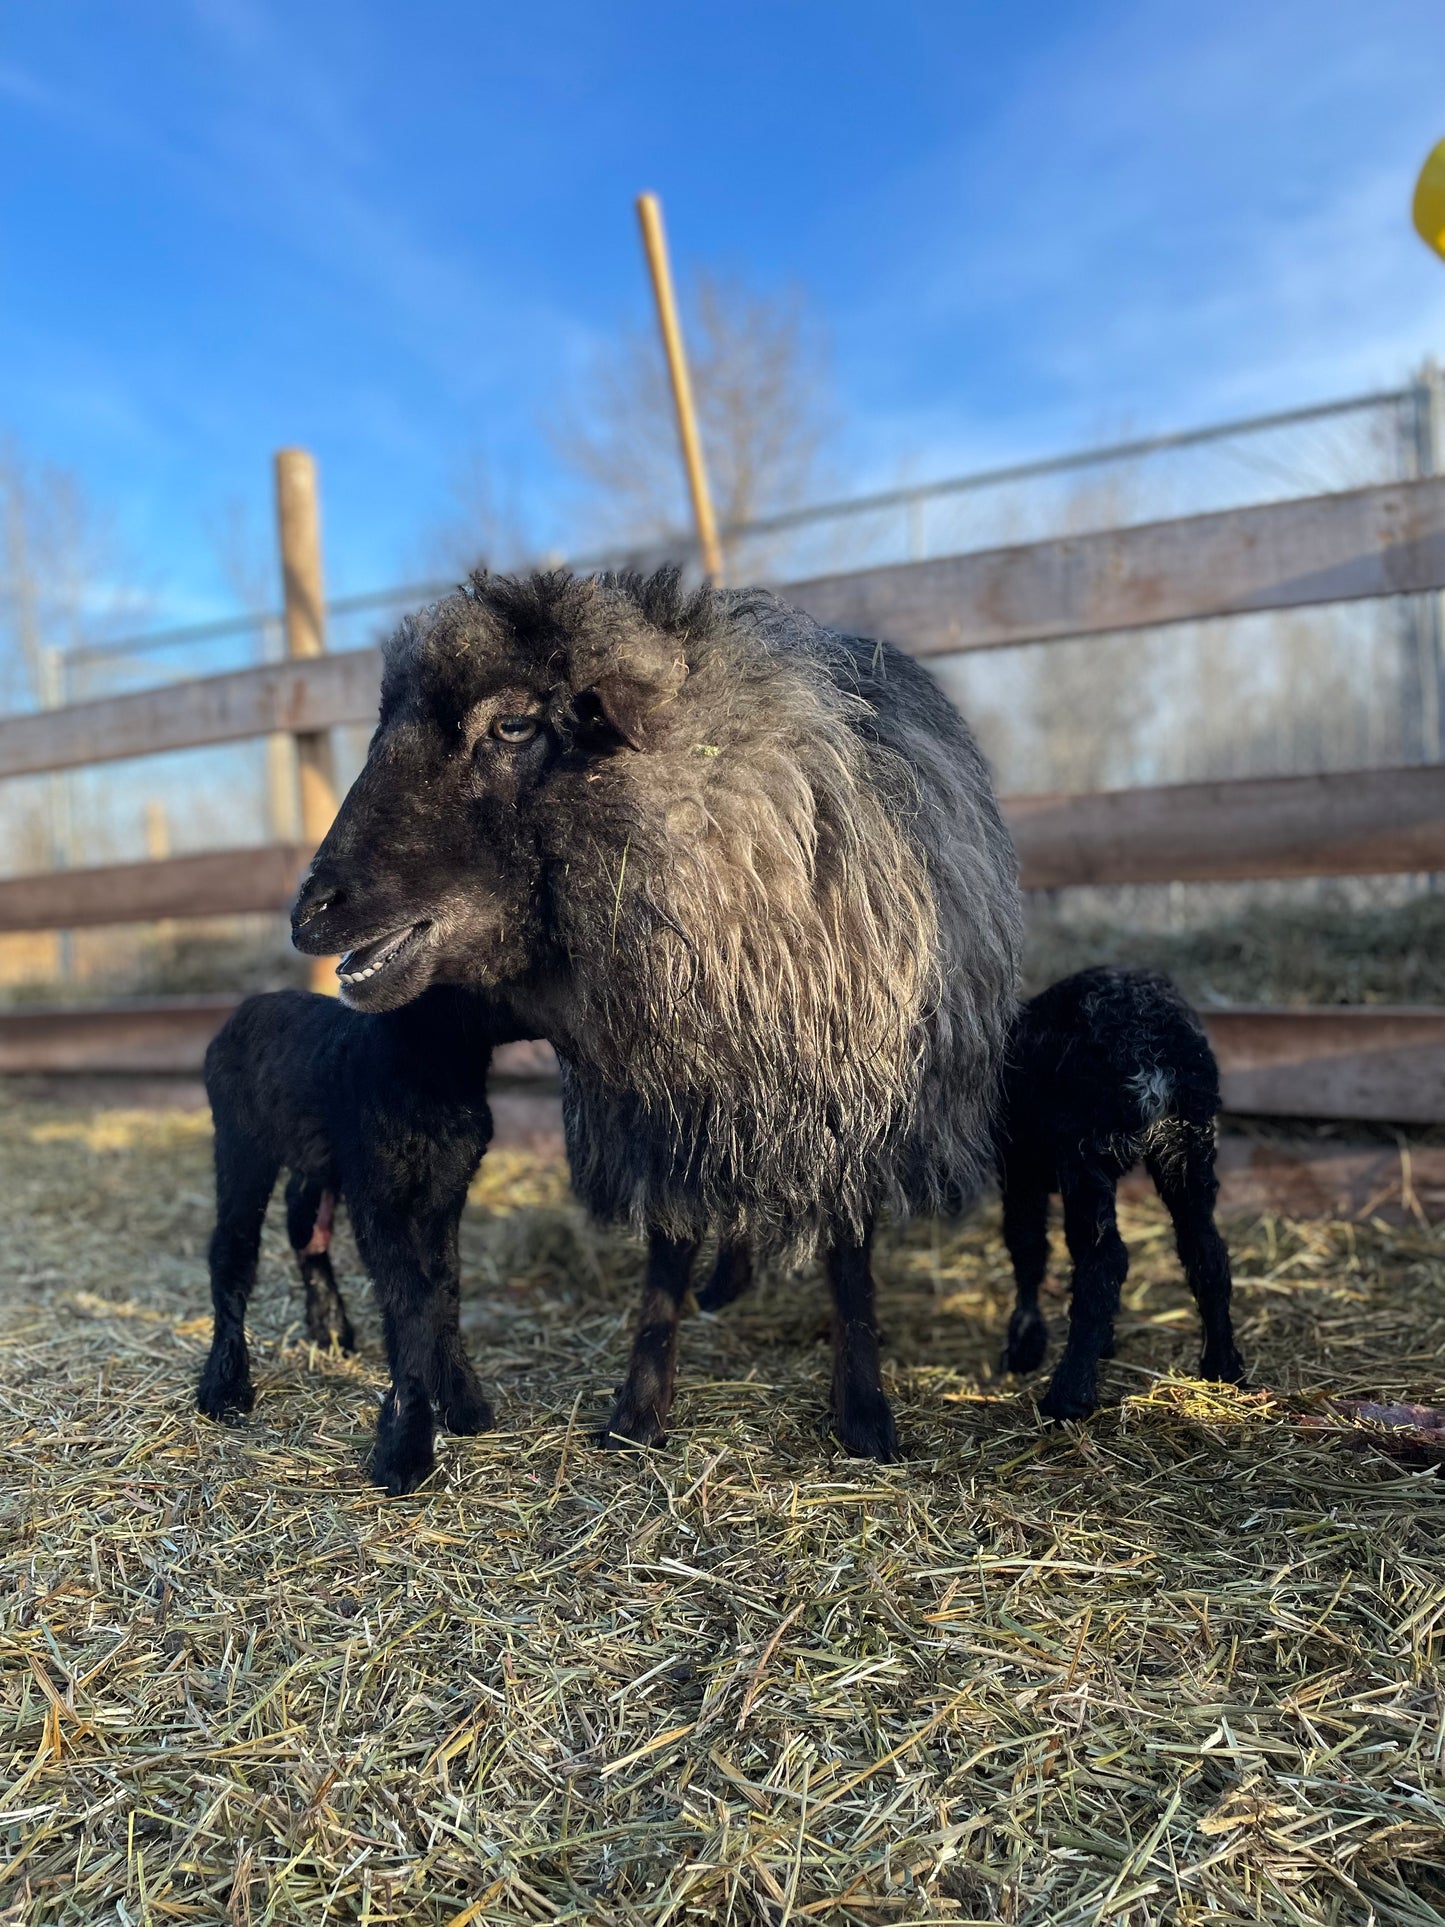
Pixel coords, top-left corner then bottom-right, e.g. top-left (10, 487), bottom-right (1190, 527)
top-left (551, 276), bottom-right (830, 562)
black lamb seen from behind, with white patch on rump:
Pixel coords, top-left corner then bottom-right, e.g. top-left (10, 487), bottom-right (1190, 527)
top-left (996, 965), bottom-right (1243, 1418)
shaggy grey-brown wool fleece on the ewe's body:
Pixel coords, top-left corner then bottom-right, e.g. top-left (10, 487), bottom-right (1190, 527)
top-left (516, 576), bottom-right (1019, 1256)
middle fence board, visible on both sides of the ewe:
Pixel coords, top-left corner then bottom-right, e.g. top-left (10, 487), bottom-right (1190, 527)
top-left (0, 765), bottom-right (1445, 931)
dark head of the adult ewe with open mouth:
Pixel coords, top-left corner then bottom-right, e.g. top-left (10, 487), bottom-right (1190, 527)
top-left (293, 578), bottom-right (686, 1010)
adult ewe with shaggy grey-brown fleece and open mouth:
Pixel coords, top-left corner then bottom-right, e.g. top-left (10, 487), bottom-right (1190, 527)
top-left (293, 570), bottom-right (1019, 1459)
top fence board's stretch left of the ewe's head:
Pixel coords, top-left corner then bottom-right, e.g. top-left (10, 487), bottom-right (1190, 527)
top-left (0, 649), bottom-right (381, 777)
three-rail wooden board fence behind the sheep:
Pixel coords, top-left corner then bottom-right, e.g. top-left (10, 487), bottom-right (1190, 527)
top-left (0, 478), bottom-right (1445, 1122)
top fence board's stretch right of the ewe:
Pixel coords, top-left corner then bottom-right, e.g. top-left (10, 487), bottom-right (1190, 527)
top-left (797, 478), bottom-right (1445, 655)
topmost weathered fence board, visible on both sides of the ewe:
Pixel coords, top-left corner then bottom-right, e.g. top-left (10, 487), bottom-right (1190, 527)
top-left (0, 478), bottom-right (1445, 777)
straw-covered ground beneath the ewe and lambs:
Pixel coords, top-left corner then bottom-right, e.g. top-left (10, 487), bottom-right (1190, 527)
top-left (0, 1102), bottom-right (1445, 1927)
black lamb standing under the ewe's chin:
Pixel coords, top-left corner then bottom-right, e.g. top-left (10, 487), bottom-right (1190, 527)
top-left (198, 987), bottom-right (520, 1491)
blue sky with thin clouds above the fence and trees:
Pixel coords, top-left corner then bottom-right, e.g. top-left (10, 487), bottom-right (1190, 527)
top-left (0, 0), bottom-right (1445, 620)
